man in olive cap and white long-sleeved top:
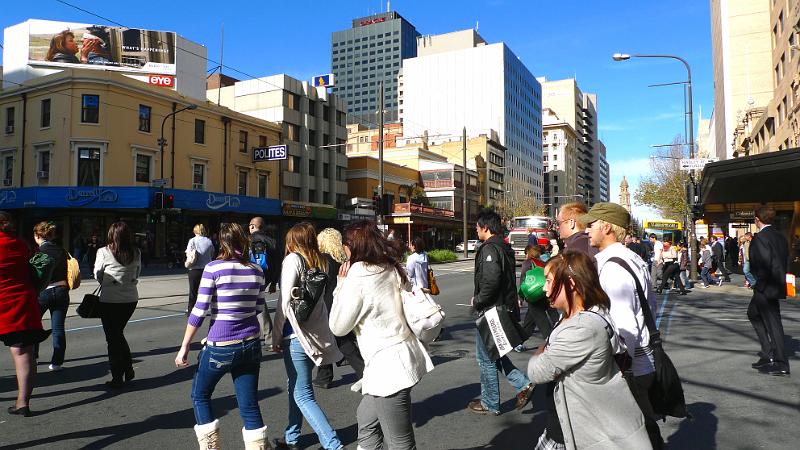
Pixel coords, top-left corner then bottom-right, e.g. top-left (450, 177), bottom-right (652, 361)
top-left (578, 202), bottom-right (664, 450)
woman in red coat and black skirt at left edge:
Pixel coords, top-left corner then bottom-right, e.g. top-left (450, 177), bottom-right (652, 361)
top-left (0, 211), bottom-right (48, 417)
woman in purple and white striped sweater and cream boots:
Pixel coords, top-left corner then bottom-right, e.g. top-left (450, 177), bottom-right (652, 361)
top-left (175, 223), bottom-right (269, 449)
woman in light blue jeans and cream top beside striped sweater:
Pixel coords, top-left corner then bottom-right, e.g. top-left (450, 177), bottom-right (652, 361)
top-left (272, 222), bottom-right (343, 450)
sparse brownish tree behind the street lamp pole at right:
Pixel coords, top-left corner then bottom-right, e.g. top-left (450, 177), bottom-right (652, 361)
top-left (634, 135), bottom-right (689, 222)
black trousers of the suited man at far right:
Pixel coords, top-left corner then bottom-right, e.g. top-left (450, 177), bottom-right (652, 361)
top-left (747, 291), bottom-right (787, 364)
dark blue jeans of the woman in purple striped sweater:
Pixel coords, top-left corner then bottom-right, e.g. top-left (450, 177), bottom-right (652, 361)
top-left (192, 339), bottom-right (264, 430)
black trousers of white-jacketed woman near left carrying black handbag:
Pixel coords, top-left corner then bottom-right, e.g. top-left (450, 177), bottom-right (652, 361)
top-left (99, 302), bottom-right (138, 379)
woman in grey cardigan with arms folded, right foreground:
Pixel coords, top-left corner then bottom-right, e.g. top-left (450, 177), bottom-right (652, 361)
top-left (528, 251), bottom-right (652, 450)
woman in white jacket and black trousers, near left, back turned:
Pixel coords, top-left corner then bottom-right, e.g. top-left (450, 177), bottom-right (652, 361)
top-left (94, 222), bottom-right (142, 388)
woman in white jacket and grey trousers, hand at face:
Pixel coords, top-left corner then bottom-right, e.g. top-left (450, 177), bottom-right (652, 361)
top-left (330, 220), bottom-right (433, 450)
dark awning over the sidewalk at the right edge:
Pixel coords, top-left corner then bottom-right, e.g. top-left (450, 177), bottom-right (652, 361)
top-left (700, 149), bottom-right (800, 205)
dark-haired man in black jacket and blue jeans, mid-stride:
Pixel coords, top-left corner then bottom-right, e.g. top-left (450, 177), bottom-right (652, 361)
top-left (467, 210), bottom-right (533, 416)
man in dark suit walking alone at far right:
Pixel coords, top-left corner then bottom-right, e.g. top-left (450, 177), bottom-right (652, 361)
top-left (747, 206), bottom-right (789, 375)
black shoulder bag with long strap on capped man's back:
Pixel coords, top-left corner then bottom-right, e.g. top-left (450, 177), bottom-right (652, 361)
top-left (608, 256), bottom-right (688, 418)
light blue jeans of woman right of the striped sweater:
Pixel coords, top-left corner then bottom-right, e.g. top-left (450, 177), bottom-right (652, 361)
top-left (283, 338), bottom-right (342, 450)
